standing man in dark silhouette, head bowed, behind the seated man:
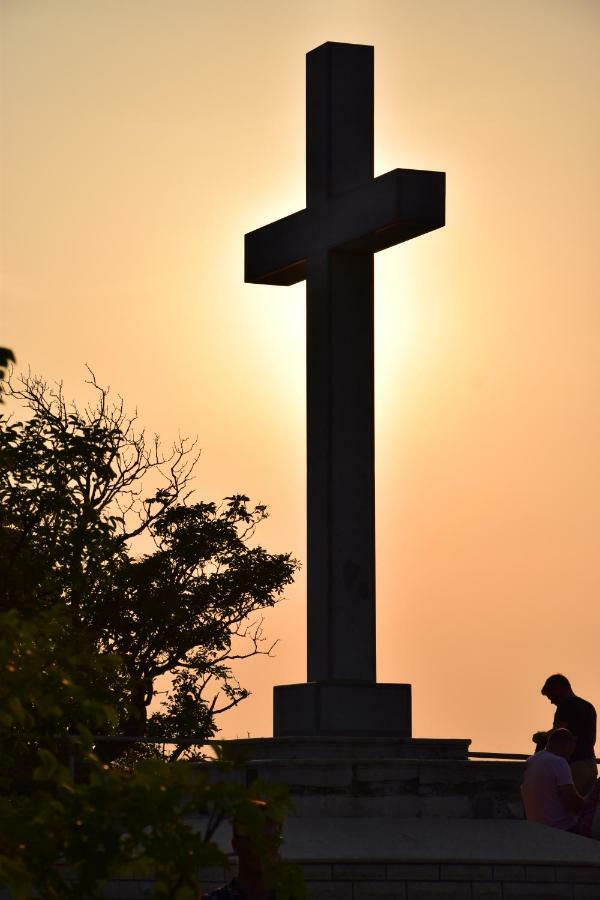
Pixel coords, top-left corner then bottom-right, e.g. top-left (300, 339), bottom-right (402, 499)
top-left (533, 674), bottom-right (598, 794)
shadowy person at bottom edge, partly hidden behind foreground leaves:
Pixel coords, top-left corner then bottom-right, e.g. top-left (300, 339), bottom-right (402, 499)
top-left (204, 800), bottom-right (281, 900)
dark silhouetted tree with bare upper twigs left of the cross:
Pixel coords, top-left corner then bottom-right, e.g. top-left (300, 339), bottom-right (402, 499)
top-left (0, 374), bottom-right (297, 758)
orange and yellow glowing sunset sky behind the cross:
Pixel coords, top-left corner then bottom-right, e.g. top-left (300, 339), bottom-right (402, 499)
top-left (0, 0), bottom-right (600, 751)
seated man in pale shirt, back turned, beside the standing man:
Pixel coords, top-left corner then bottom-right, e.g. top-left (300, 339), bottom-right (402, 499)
top-left (521, 728), bottom-right (583, 830)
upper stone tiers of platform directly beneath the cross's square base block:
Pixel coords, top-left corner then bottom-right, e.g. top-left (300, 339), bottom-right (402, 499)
top-left (201, 737), bottom-right (525, 820)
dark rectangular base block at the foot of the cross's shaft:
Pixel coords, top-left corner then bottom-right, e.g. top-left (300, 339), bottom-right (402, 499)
top-left (273, 681), bottom-right (412, 738)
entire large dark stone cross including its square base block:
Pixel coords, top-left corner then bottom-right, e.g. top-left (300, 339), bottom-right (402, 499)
top-left (245, 43), bottom-right (445, 736)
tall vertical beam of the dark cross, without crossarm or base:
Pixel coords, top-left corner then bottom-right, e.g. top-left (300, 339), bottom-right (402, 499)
top-left (306, 44), bottom-right (376, 682)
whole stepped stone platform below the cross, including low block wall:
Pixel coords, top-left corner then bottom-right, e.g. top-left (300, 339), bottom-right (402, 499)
top-left (192, 736), bottom-right (600, 900)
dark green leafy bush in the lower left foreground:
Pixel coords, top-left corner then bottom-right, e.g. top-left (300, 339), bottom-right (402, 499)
top-left (0, 608), bottom-right (303, 900)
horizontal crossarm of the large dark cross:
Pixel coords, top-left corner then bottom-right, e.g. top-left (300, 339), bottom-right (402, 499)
top-left (245, 169), bottom-right (446, 285)
